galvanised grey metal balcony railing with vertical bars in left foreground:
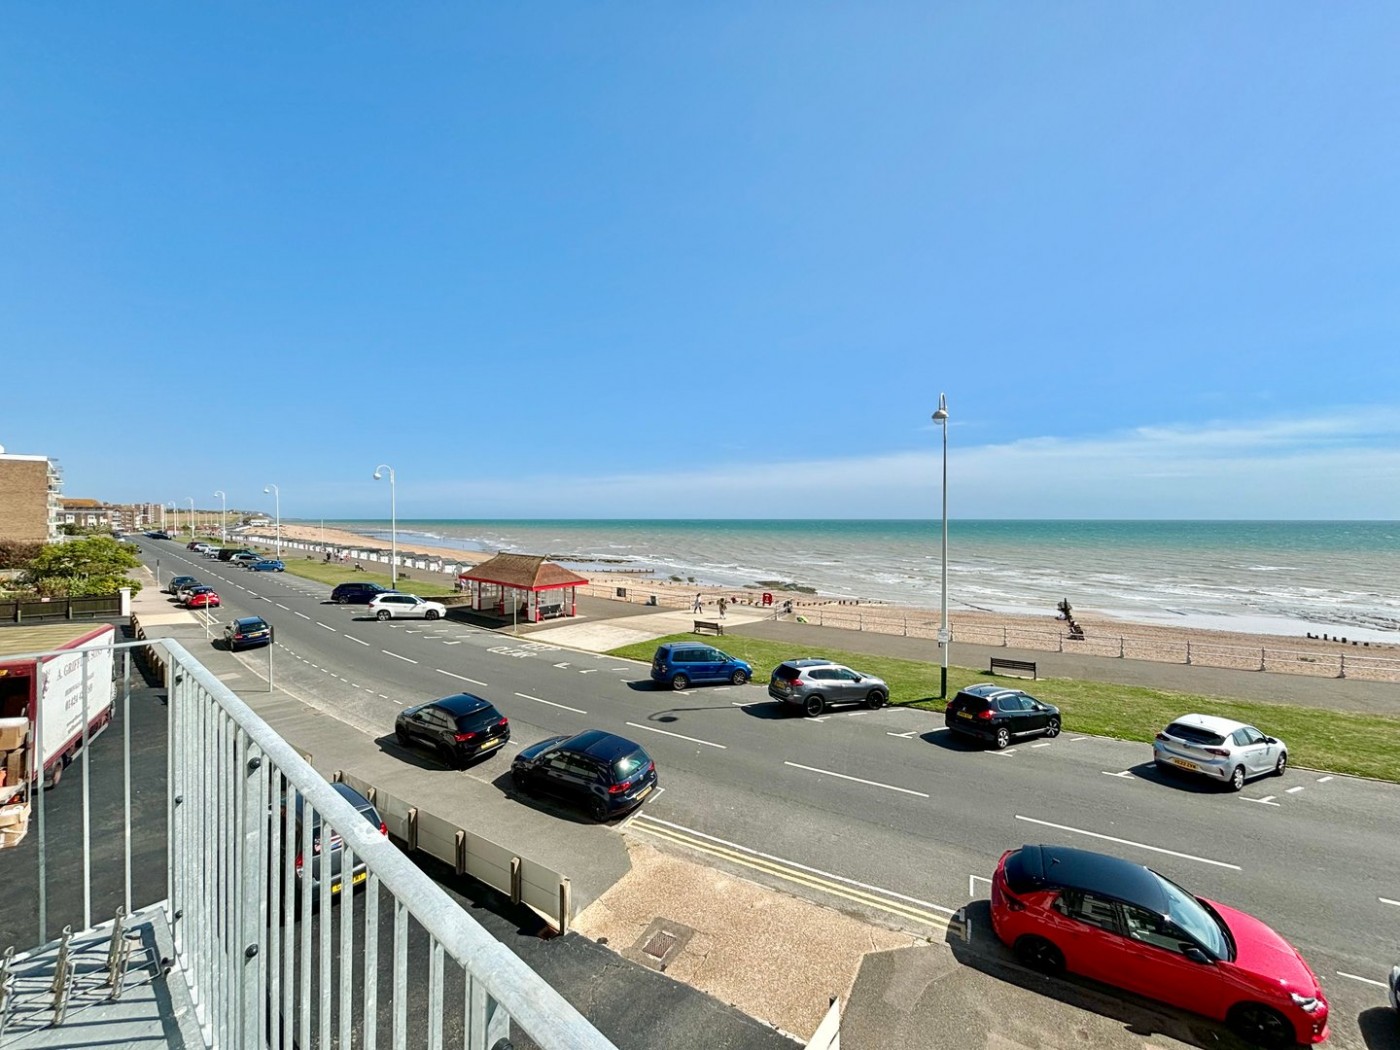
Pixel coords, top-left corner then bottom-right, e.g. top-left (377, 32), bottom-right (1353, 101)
top-left (0, 640), bottom-right (612, 1050)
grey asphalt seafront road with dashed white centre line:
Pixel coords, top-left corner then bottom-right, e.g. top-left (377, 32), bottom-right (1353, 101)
top-left (136, 545), bottom-right (1400, 1046)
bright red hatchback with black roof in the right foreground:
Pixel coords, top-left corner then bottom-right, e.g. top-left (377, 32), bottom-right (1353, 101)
top-left (991, 846), bottom-right (1327, 1047)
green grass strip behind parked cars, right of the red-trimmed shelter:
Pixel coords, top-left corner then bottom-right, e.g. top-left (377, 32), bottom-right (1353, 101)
top-left (609, 634), bottom-right (1400, 781)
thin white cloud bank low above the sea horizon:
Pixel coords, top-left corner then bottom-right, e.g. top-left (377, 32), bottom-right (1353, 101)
top-left (317, 409), bottom-right (1400, 519)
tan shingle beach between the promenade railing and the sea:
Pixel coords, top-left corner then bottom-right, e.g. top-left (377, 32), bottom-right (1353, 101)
top-left (264, 525), bottom-right (1400, 675)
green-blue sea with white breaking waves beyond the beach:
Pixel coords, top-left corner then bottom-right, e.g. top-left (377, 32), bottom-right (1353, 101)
top-left (328, 519), bottom-right (1400, 644)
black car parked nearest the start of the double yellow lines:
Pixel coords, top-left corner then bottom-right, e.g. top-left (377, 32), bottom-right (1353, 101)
top-left (511, 729), bottom-right (657, 820)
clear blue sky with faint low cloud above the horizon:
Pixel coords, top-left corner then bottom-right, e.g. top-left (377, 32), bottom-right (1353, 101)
top-left (0, 3), bottom-right (1400, 518)
